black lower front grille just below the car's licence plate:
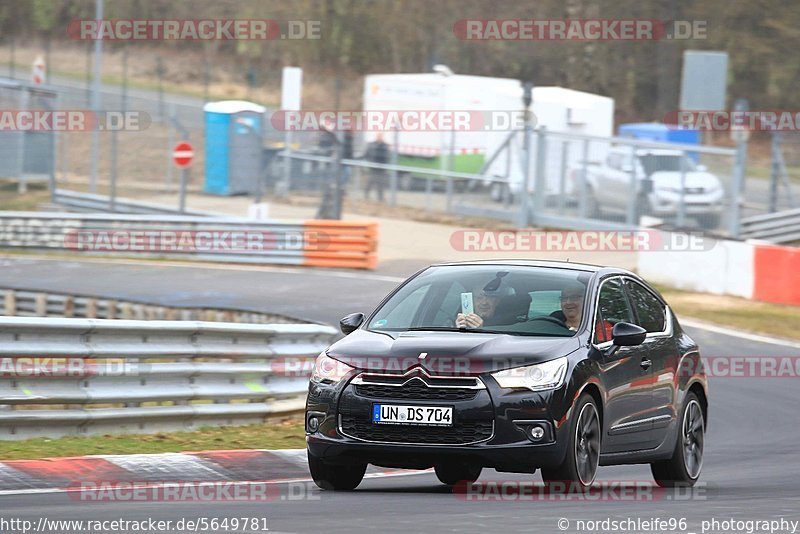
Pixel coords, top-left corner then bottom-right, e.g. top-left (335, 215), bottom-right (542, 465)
top-left (339, 415), bottom-right (494, 445)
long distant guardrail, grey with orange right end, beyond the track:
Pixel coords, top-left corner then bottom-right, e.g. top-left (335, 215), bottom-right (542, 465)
top-left (0, 212), bottom-right (378, 269)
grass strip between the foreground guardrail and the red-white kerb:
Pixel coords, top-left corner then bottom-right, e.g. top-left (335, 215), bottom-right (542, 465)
top-left (0, 417), bottom-right (306, 460)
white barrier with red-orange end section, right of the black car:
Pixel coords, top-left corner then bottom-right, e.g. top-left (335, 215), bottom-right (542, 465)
top-left (637, 230), bottom-right (800, 305)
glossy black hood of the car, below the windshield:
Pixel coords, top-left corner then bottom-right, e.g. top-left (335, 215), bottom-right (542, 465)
top-left (327, 330), bottom-right (580, 376)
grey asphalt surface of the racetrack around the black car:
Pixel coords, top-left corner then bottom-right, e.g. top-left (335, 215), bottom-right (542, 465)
top-left (0, 258), bottom-right (800, 533)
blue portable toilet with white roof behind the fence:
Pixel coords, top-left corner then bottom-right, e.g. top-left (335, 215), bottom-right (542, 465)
top-left (203, 100), bottom-right (267, 195)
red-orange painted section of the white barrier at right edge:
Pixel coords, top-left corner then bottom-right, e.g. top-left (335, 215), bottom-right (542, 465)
top-left (753, 245), bottom-right (800, 305)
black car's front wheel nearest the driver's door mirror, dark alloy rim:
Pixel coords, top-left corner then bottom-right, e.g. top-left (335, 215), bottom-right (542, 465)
top-left (542, 394), bottom-right (602, 489)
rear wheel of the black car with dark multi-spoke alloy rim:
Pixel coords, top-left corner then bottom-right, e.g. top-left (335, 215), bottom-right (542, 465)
top-left (650, 393), bottom-right (706, 488)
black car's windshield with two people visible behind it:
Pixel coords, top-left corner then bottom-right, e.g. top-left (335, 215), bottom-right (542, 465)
top-left (368, 265), bottom-right (591, 337)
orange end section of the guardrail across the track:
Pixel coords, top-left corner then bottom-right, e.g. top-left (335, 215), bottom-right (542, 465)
top-left (303, 219), bottom-right (378, 269)
